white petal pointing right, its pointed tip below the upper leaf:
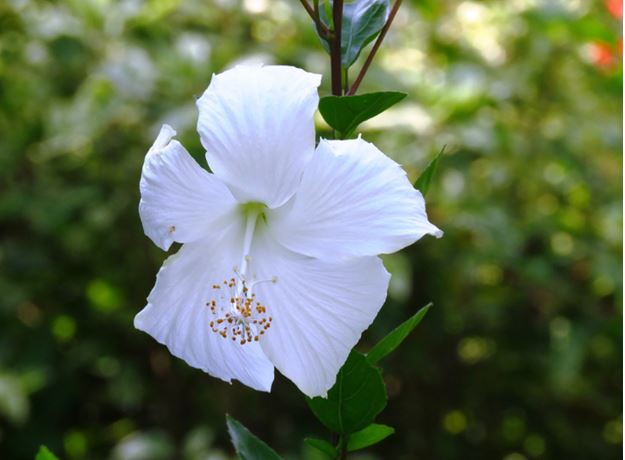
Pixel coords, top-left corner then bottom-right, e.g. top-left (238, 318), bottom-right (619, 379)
top-left (268, 139), bottom-right (443, 259)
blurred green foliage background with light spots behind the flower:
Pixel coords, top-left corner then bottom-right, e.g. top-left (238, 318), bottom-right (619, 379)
top-left (0, 0), bottom-right (623, 460)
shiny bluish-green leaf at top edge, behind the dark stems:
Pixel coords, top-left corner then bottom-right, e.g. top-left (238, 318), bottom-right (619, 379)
top-left (319, 0), bottom-right (390, 68)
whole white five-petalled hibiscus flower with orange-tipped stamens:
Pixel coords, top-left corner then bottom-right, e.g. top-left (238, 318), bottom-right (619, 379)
top-left (135, 66), bottom-right (442, 396)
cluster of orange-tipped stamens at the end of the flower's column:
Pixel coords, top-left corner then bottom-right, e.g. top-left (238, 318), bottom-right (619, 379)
top-left (206, 268), bottom-right (277, 345)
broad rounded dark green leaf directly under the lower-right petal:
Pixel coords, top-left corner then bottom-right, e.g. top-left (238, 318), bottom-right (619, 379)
top-left (306, 350), bottom-right (386, 435)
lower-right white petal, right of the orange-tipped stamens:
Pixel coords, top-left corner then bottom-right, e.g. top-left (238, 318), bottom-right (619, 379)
top-left (250, 232), bottom-right (390, 397)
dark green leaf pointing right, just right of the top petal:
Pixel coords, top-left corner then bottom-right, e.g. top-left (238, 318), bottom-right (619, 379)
top-left (319, 91), bottom-right (406, 138)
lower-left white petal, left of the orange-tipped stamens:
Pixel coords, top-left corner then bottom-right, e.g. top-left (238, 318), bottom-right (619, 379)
top-left (135, 228), bottom-right (273, 391)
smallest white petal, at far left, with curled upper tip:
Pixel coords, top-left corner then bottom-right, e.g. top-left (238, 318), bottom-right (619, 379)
top-left (139, 125), bottom-right (237, 251)
